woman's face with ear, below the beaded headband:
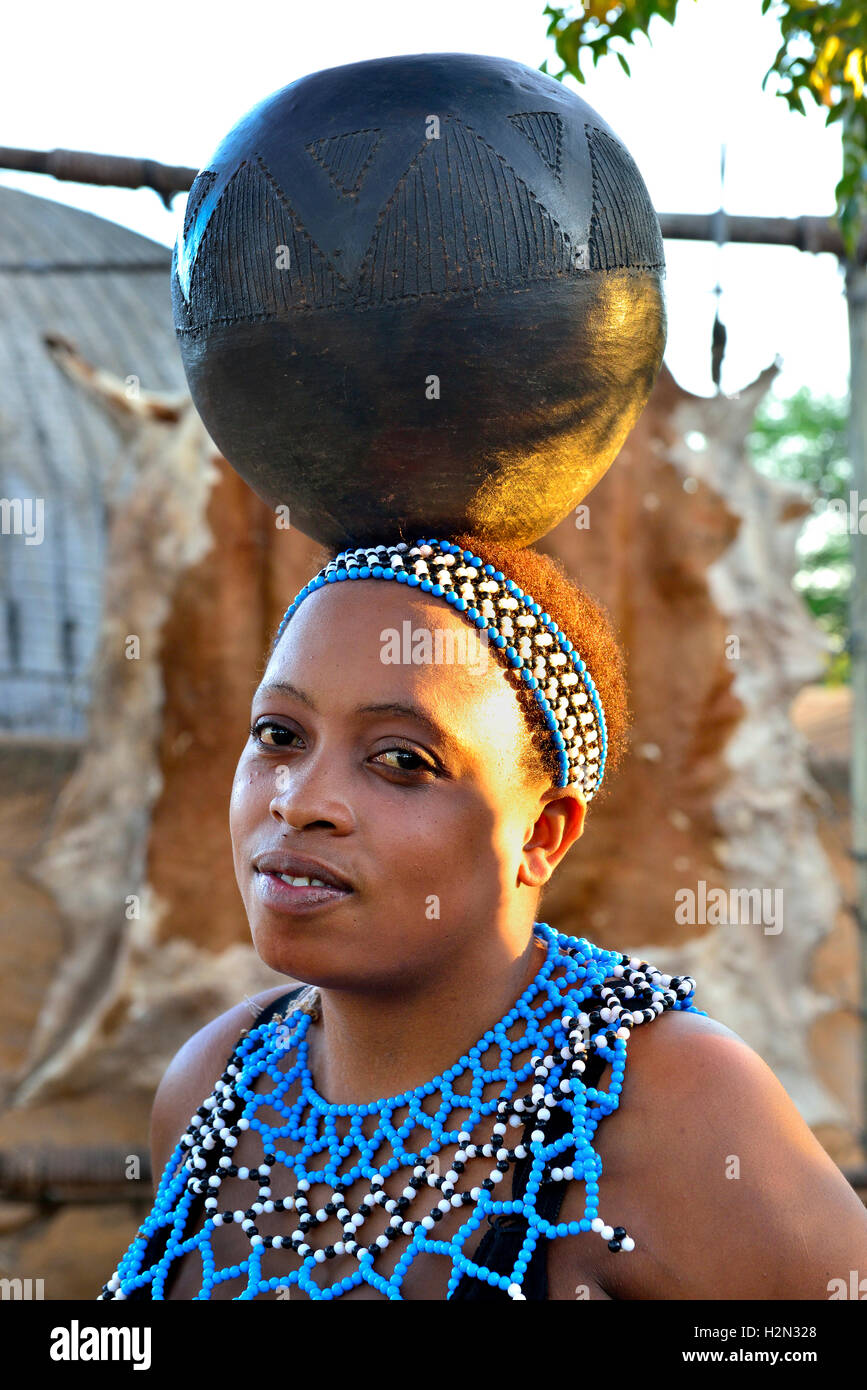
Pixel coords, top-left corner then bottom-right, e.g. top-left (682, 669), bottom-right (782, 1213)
top-left (229, 581), bottom-right (585, 990)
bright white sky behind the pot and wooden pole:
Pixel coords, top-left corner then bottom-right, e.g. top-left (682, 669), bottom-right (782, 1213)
top-left (0, 0), bottom-right (849, 396)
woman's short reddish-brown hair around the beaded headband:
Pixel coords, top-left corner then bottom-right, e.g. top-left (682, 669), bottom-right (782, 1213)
top-left (300, 531), bottom-right (629, 801)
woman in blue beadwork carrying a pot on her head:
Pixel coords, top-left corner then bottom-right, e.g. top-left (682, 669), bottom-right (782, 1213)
top-left (100, 535), bottom-right (867, 1300)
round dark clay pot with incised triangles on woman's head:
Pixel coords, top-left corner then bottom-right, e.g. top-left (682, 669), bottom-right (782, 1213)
top-left (172, 53), bottom-right (666, 546)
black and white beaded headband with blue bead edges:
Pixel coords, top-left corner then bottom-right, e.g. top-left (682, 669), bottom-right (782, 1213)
top-left (274, 539), bottom-right (607, 801)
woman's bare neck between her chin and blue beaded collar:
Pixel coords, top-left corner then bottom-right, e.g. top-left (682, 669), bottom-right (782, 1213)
top-left (307, 935), bottom-right (545, 1105)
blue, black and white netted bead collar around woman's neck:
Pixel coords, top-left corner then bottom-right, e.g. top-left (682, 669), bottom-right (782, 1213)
top-left (99, 922), bottom-right (703, 1300)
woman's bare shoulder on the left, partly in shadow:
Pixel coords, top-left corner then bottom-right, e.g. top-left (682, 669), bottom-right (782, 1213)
top-left (150, 980), bottom-right (292, 1190)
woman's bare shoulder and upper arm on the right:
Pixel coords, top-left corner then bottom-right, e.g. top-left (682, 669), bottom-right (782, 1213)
top-left (597, 1011), bottom-right (867, 1300)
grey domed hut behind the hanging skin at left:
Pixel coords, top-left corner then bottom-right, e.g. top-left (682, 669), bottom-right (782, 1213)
top-left (0, 188), bottom-right (185, 737)
